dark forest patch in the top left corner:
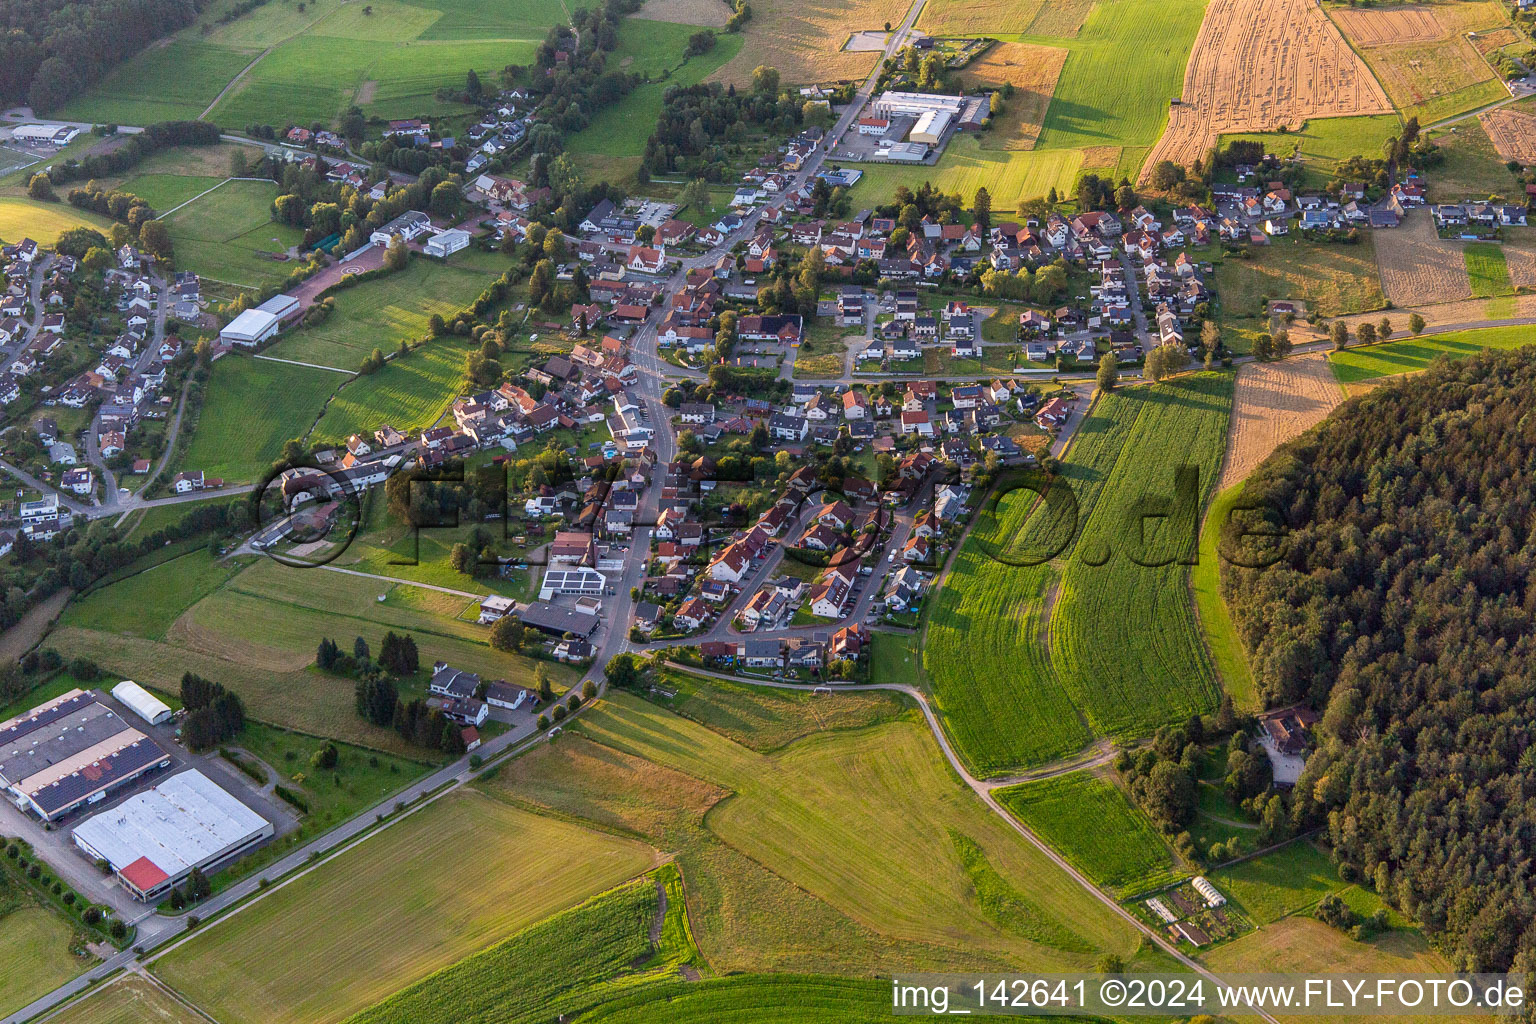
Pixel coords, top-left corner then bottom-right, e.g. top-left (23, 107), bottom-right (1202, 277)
top-left (0, 0), bottom-right (204, 114)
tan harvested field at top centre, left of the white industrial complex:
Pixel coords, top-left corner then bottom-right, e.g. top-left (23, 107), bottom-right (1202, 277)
top-left (710, 0), bottom-right (909, 86)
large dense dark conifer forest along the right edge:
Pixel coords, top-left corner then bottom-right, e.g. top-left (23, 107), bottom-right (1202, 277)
top-left (1223, 348), bottom-right (1536, 970)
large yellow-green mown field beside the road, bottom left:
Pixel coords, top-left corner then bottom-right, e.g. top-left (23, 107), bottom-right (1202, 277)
top-left (154, 791), bottom-right (656, 1024)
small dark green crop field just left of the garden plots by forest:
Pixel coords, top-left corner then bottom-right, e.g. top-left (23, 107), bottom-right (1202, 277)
top-left (995, 771), bottom-right (1181, 897)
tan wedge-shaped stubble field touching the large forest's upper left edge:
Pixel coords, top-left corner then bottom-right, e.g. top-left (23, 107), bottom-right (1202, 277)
top-left (1217, 352), bottom-right (1344, 493)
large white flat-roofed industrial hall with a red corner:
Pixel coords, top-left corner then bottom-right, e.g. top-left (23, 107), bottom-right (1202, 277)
top-left (74, 769), bottom-right (273, 901)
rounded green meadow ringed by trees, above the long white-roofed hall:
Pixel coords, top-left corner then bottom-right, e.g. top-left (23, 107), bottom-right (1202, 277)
top-left (166, 181), bottom-right (304, 289)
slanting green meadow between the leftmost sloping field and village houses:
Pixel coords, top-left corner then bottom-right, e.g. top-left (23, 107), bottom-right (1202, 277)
top-left (313, 335), bottom-right (478, 442)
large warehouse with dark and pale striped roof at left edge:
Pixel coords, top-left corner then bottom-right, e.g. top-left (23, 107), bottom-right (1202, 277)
top-left (0, 689), bottom-right (170, 821)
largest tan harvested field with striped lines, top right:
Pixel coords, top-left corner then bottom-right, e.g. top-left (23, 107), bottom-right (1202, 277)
top-left (1141, 0), bottom-right (1392, 181)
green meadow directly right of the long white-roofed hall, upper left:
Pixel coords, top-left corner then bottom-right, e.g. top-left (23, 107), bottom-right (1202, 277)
top-left (264, 257), bottom-right (495, 369)
